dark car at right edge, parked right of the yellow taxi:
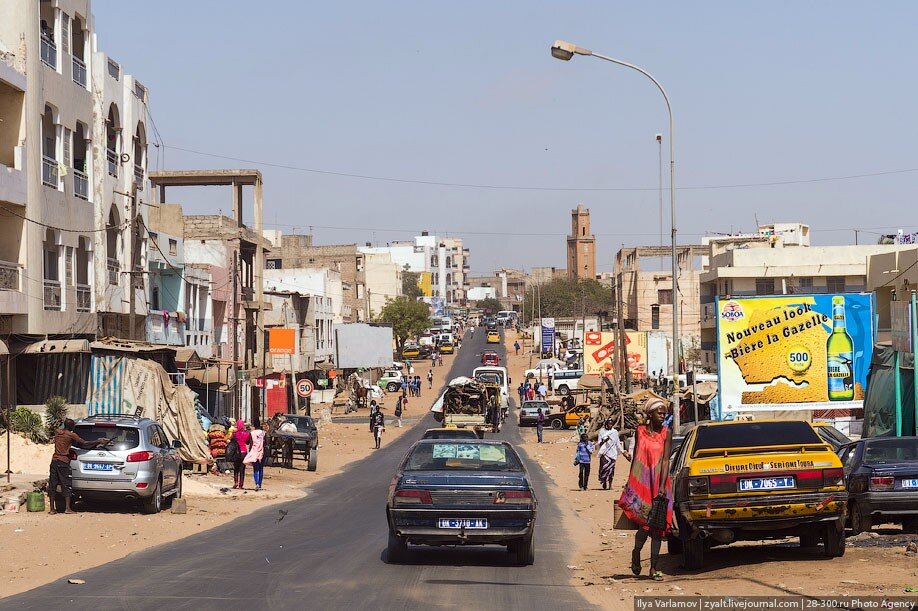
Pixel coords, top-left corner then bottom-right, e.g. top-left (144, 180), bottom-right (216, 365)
top-left (838, 437), bottom-right (918, 534)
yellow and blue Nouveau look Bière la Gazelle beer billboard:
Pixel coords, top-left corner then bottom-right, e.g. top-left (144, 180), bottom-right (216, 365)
top-left (717, 293), bottom-right (874, 419)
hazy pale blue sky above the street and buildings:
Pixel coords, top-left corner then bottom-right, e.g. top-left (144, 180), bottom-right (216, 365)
top-left (92, 0), bottom-right (918, 274)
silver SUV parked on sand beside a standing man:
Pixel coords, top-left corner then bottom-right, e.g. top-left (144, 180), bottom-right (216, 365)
top-left (70, 414), bottom-right (182, 513)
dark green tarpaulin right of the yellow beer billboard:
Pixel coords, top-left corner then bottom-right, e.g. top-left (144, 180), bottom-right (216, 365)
top-left (863, 346), bottom-right (915, 437)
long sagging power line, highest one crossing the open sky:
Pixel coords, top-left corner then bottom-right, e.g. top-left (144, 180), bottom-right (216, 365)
top-left (161, 141), bottom-right (918, 192)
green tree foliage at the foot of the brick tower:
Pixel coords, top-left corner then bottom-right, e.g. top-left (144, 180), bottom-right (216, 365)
top-left (525, 278), bottom-right (613, 321)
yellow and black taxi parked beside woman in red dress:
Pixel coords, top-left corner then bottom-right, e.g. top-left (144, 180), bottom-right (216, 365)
top-left (668, 420), bottom-right (848, 569)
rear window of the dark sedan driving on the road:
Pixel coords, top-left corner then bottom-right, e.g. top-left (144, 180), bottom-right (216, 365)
top-left (404, 441), bottom-right (523, 471)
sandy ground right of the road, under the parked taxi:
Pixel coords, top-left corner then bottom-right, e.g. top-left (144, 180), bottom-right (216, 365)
top-left (507, 333), bottom-right (918, 609)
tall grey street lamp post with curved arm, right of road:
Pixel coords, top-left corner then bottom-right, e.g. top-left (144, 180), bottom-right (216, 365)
top-left (551, 40), bottom-right (679, 431)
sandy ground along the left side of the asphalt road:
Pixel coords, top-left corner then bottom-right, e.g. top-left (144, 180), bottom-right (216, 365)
top-left (0, 346), bottom-right (454, 597)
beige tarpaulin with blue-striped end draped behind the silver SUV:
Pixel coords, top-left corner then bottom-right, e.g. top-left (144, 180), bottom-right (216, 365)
top-left (88, 354), bottom-right (210, 462)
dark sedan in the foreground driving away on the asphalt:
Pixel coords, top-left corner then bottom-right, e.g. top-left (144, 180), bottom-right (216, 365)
top-left (386, 439), bottom-right (537, 565)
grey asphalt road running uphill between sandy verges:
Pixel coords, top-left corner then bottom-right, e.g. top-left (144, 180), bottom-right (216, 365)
top-left (0, 329), bottom-right (589, 611)
